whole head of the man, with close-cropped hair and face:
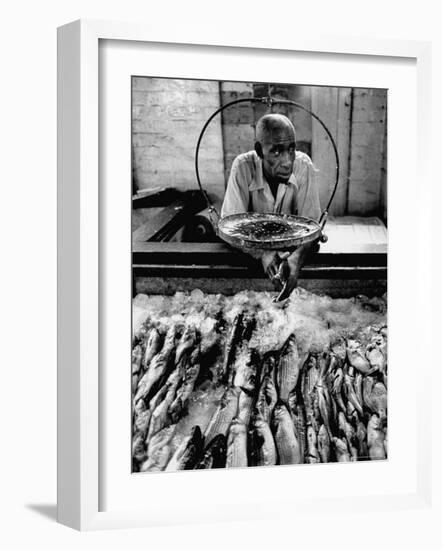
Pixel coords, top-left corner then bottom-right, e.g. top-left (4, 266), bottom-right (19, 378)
top-left (255, 114), bottom-right (296, 186)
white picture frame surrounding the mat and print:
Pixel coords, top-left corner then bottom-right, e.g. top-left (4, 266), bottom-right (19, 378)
top-left (57, 21), bottom-right (431, 530)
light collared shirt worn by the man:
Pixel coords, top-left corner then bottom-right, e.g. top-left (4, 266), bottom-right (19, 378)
top-left (221, 151), bottom-right (321, 221)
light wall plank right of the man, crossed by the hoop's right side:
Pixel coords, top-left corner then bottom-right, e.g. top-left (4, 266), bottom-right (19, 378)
top-left (311, 86), bottom-right (351, 216)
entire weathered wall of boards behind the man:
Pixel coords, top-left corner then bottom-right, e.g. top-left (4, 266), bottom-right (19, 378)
top-left (133, 77), bottom-right (387, 220)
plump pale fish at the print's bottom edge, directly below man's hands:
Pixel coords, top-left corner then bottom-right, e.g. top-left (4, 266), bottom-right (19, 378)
top-left (272, 401), bottom-right (303, 464)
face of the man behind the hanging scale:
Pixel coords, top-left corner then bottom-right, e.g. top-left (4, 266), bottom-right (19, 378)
top-left (261, 127), bottom-right (296, 183)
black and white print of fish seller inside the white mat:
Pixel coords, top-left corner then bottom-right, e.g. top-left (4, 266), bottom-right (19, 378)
top-left (128, 74), bottom-right (388, 474)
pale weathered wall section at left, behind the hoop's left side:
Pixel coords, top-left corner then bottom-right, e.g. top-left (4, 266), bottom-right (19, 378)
top-left (132, 77), bottom-right (224, 201)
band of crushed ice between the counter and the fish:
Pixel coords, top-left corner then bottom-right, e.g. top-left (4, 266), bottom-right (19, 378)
top-left (133, 289), bottom-right (386, 354)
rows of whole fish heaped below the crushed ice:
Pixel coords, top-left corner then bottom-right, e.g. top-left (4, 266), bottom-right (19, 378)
top-left (132, 288), bottom-right (387, 472)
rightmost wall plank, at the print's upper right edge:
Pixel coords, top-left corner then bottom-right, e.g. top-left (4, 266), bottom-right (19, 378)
top-left (348, 89), bottom-right (387, 216)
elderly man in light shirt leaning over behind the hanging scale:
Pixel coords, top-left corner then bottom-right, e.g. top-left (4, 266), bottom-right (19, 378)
top-left (221, 114), bottom-right (321, 299)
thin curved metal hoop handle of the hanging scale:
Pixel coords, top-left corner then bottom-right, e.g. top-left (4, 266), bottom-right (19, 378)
top-left (195, 97), bottom-right (339, 229)
